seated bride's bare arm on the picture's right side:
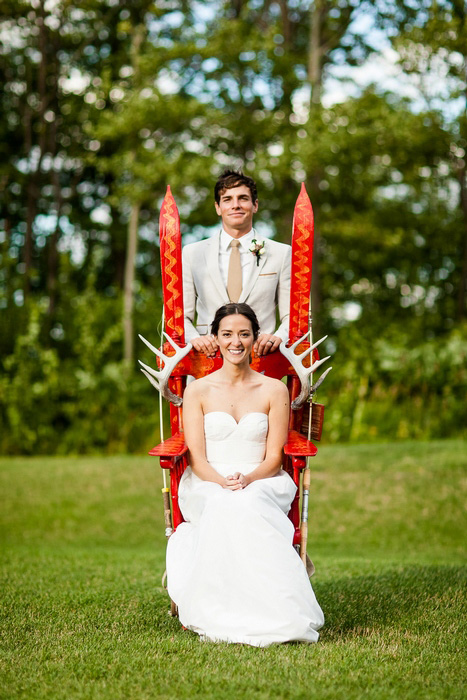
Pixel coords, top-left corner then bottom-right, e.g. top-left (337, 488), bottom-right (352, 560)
top-left (241, 382), bottom-right (289, 487)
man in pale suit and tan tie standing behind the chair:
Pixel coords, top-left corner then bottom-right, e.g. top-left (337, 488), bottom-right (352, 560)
top-left (182, 170), bottom-right (291, 357)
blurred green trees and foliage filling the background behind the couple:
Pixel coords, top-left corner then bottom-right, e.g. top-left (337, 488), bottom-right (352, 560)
top-left (0, 0), bottom-right (467, 451)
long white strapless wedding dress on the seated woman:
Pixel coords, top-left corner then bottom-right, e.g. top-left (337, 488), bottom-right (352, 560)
top-left (167, 411), bottom-right (324, 647)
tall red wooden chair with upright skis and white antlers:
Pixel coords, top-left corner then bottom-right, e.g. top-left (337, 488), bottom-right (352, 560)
top-left (140, 185), bottom-right (331, 608)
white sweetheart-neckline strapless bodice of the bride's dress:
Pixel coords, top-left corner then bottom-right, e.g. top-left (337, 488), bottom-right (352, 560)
top-left (204, 411), bottom-right (268, 467)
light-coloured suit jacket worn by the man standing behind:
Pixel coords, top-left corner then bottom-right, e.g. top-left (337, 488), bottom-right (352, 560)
top-left (182, 233), bottom-right (292, 342)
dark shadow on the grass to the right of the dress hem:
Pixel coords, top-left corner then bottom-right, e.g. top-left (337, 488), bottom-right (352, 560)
top-left (316, 566), bottom-right (467, 641)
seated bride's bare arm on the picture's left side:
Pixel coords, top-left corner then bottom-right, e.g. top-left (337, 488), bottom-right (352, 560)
top-left (183, 382), bottom-right (226, 488)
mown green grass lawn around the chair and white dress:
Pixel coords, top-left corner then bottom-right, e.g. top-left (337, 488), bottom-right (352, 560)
top-left (0, 440), bottom-right (467, 700)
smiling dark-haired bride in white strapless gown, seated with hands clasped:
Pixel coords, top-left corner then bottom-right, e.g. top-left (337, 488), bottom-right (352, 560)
top-left (167, 303), bottom-right (324, 647)
